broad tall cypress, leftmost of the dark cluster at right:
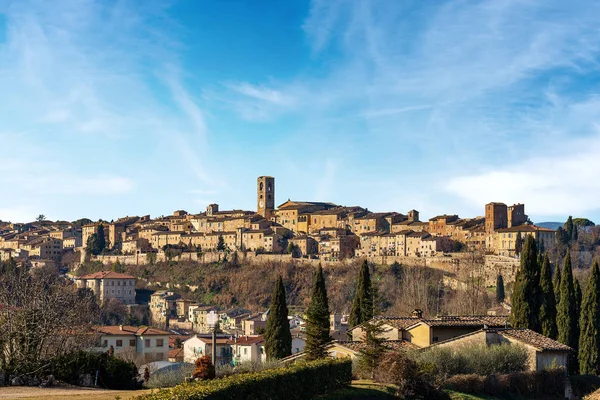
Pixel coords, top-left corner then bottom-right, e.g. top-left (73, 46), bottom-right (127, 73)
top-left (510, 235), bottom-right (541, 332)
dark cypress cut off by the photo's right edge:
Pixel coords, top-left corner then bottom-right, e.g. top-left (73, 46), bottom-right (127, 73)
top-left (579, 262), bottom-right (600, 375)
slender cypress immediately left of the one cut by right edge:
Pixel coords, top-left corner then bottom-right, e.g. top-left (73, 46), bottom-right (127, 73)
top-left (556, 250), bottom-right (579, 372)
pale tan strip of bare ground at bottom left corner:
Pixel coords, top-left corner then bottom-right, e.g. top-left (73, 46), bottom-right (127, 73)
top-left (0, 386), bottom-right (149, 400)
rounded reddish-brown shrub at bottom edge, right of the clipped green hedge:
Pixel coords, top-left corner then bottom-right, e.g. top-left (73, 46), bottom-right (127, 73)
top-left (375, 352), bottom-right (438, 399)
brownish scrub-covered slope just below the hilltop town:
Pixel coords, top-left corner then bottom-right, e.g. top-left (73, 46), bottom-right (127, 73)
top-left (78, 260), bottom-right (490, 315)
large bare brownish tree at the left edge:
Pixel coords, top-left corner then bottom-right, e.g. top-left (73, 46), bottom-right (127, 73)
top-left (0, 267), bottom-right (98, 374)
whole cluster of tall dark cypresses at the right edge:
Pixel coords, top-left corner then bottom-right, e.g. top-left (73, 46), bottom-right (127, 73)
top-left (510, 236), bottom-right (600, 375)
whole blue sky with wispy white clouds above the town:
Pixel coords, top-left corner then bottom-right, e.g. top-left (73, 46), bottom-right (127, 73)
top-left (0, 0), bottom-right (600, 222)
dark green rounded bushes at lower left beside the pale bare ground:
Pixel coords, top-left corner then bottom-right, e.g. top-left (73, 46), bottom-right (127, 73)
top-left (46, 351), bottom-right (138, 389)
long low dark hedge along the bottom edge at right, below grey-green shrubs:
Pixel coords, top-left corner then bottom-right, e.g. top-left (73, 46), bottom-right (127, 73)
top-left (444, 369), bottom-right (565, 399)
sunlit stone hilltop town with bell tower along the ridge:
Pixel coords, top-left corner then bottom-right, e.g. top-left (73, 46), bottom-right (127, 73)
top-left (0, 176), bottom-right (555, 266)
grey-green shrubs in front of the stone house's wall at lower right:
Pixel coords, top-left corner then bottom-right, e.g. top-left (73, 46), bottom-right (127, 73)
top-left (415, 344), bottom-right (529, 378)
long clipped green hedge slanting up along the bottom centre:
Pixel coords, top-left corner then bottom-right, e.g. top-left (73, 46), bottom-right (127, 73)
top-left (136, 359), bottom-right (352, 400)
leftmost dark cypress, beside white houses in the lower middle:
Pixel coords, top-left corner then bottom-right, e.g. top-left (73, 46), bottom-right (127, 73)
top-left (265, 275), bottom-right (292, 360)
